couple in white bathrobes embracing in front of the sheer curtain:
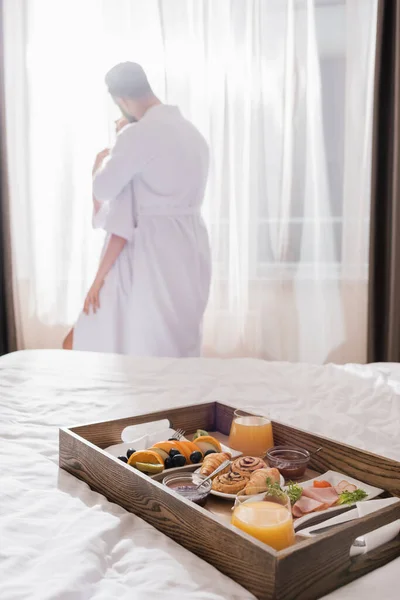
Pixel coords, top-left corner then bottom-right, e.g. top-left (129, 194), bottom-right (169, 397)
top-left (73, 63), bottom-right (211, 357)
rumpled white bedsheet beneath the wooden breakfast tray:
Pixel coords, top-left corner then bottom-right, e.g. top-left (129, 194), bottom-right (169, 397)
top-left (0, 351), bottom-right (400, 600)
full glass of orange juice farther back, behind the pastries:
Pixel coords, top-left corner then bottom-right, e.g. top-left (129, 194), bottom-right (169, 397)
top-left (228, 410), bottom-right (274, 457)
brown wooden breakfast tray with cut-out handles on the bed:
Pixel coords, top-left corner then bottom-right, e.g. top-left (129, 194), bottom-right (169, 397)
top-left (59, 402), bottom-right (400, 600)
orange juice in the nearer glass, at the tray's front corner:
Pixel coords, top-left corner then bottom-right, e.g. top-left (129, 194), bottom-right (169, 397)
top-left (232, 501), bottom-right (294, 550)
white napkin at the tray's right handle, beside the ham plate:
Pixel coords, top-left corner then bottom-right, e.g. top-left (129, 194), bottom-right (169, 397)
top-left (350, 498), bottom-right (400, 556)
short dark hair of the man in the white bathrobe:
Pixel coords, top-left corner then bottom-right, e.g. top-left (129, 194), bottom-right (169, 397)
top-left (106, 62), bottom-right (152, 99)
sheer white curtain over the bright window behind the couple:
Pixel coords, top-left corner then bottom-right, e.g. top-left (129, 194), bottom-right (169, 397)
top-left (5, 0), bottom-right (377, 363)
